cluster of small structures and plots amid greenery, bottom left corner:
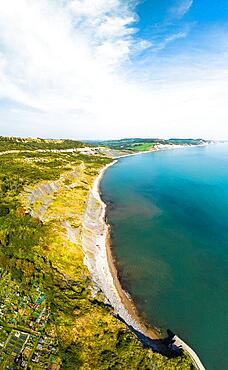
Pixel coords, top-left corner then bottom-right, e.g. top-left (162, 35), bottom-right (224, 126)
top-left (0, 271), bottom-right (61, 370)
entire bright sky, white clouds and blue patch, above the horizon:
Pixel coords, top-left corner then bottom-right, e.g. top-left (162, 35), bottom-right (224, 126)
top-left (0, 0), bottom-right (228, 140)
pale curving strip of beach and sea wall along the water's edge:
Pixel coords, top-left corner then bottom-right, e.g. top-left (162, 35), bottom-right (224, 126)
top-left (82, 146), bottom-right (205, 370)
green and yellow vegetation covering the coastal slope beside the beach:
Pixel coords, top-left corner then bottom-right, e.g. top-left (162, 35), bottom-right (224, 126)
top-left (0, 138), bottom-right (193, 370)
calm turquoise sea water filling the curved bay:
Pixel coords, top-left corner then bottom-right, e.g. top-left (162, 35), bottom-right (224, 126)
top-left (101, 144), bottom-right (228, 370)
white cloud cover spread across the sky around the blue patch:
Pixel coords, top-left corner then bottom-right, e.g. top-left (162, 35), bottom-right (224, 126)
top-left (0, 0), bottom-right (228, 138)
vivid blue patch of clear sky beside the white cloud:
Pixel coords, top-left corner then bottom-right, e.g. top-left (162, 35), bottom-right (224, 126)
top-left (133, 0), bottom-right (228, 63)
